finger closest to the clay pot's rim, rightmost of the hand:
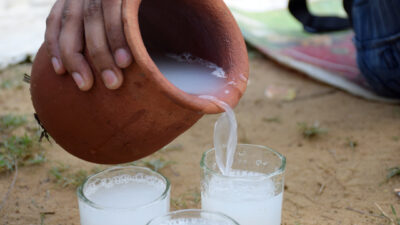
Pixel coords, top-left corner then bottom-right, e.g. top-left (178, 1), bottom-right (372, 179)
top-left (102, 0), bottom-right (133, 68)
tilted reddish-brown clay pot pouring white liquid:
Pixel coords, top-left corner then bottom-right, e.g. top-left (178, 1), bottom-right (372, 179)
top-left (31, 0), bottom-right (248, 164)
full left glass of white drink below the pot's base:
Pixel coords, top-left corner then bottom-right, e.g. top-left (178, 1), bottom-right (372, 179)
top-left (77, 166), bottom-right (170, 225)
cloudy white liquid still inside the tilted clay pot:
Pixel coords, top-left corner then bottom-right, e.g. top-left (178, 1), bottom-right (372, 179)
top-left (152, 54), bottom-right (227, 95)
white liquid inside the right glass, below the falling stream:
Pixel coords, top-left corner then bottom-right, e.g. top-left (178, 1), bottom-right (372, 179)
top-left (201, 171), bottom-right (283, 225)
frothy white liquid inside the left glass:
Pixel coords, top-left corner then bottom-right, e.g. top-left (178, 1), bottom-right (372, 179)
top-left (79, 174), bottom-right (169, 225)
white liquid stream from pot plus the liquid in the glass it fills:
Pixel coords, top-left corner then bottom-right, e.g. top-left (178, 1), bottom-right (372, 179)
top-left (200, 96), bottom-right (283, 225)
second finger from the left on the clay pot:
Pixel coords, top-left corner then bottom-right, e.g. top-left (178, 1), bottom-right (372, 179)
top-left (59, 0), bottom-right (93, 91)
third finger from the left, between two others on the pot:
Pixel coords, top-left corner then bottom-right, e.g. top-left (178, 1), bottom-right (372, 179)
top-left (84, 0), bottom-right (123, 89)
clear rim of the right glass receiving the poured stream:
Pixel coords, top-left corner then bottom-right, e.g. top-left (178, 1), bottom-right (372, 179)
top-left (200, 144), bottom-right (286, 180)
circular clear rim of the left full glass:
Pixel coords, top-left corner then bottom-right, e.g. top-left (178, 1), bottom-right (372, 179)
top-left (76, 166), bottom-right (171, 210)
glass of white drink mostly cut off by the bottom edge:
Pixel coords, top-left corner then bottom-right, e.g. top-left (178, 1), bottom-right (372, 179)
top-left (147, 209), bottom-right (239, 225)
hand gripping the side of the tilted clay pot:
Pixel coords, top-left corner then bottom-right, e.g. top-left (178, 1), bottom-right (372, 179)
top-left (45, 0), bottom-right (133, 91)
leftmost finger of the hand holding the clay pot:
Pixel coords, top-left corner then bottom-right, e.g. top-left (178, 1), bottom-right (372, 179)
top-left (45, 0), bottom-right (65, 74)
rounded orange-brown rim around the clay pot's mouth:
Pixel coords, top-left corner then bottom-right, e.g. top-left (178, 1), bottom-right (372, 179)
top-left (122, 0), bottom-right (249, 114)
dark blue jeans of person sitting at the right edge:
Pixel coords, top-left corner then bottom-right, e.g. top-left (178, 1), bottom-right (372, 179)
top-left (351, 0), bottom-right (400, 98)
